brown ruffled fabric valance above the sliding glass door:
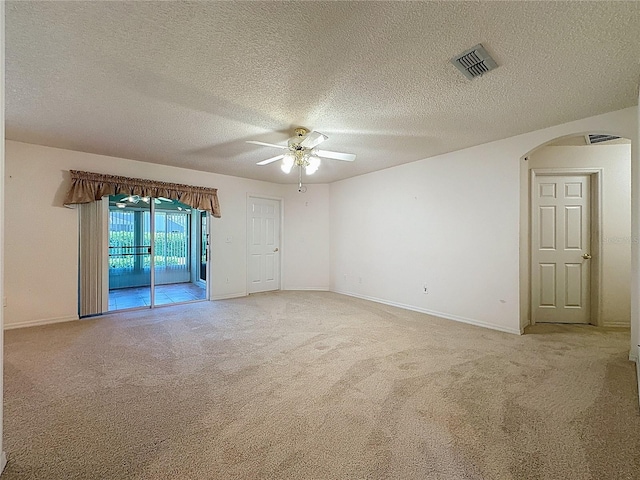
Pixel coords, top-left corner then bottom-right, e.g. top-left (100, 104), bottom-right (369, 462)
top-left (64, 170), bottom-right (220, 217)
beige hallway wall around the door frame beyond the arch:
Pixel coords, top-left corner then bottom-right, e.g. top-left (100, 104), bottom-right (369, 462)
top-left (527, 144), bottom-right (631, 326)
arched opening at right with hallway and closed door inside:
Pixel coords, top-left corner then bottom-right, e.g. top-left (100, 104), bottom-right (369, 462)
top-left (520, 134), bottom-right (633, 330)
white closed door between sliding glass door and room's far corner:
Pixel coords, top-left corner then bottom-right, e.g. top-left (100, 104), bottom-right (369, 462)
top-left (247, 197), bottom-right (280, 293)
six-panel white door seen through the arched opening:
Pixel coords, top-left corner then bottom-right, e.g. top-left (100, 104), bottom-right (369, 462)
top-left (531, 175), bottom-right (591, 323)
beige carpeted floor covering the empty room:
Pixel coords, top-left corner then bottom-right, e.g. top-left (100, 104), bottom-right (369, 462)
top-left (2, 292), bottom-right (640, 480)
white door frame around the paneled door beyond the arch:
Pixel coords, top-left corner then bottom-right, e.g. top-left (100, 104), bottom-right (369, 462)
top-left (527, 167), bottom-right (603, 326)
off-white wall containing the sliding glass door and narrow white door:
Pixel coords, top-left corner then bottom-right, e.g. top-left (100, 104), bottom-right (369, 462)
top-left (5, 141), bottom-right (329, 326)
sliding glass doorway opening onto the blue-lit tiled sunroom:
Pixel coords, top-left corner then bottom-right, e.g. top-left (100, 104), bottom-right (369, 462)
top-left (108, 195), bottom-right (209, 311)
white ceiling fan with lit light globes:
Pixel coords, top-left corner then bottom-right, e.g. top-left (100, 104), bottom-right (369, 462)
top-left (247, 127), bottom-right (356, 175)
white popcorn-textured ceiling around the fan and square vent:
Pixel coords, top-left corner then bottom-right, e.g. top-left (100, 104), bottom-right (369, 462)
top-left (6, 1), bottom-right (640, 183)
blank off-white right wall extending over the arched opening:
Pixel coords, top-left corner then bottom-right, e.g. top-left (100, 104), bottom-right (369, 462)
top-left (331, 107), bottom-right (637, 333)
